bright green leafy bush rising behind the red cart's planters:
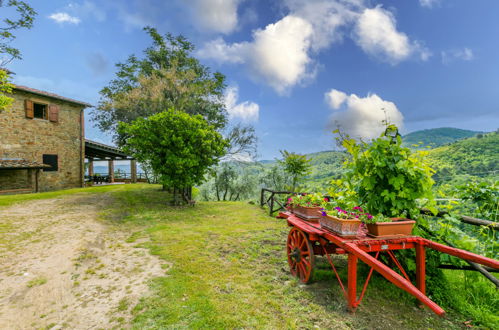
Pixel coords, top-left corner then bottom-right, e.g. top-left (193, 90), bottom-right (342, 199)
top-left (342, 125), bottom-right (434, 218)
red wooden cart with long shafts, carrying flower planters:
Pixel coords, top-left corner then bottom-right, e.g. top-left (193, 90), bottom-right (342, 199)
top-left (278, 212), bottom-right (499, 315)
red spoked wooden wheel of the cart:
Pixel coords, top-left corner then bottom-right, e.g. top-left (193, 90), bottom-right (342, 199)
top-left (287, 227), bottom-right (315, 283)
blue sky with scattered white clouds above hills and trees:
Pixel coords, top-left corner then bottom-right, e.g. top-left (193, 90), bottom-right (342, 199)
top-left (0, 0), bottom-right (499, 159)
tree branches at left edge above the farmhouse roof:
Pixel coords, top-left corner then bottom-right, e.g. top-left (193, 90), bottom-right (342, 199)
top-left (0, 0), bottom-right (36, 111)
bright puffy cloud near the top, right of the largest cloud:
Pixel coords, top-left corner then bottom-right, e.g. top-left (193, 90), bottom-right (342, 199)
top-left (354, 6), bottom-right (430, 64)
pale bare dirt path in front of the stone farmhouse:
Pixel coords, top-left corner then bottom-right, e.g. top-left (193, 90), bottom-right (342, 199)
top-left (0, 194), bottom-right (165, 329)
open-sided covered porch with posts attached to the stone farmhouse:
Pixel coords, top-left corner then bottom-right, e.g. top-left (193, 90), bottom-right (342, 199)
top-left (85, 139), bottom-right (137, 183)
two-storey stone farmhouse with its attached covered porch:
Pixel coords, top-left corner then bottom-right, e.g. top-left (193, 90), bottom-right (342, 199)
top-left (0, 85), bottom-right (136, 194)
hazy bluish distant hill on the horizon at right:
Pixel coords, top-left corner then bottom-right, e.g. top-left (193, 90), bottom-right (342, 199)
top-left (402, 127), bottom-right (483, 148)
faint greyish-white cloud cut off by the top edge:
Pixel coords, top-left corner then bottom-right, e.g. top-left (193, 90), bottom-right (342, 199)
top-left (188, 0), bottom-right (240, 34)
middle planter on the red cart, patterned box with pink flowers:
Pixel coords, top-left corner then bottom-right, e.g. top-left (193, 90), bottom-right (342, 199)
top-left (319, 202), bottom-right (361, 237)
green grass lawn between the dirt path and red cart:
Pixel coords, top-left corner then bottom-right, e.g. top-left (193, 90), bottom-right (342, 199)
top-left (0, 184), bottom-right (470, 329)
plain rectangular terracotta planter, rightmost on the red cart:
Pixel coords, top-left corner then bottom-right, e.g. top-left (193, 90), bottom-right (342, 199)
top-left (360, 213), bottom-right (416, 237)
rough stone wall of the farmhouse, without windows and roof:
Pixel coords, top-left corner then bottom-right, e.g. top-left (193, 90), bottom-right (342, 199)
top-left (0, 90), bottom-right (85, 191)
